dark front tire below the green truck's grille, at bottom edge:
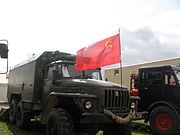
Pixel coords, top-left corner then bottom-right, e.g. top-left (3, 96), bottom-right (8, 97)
top-left (103, 124), bottom-right (131, 135)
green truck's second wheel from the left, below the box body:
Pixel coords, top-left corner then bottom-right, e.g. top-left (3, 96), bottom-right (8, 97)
top-left (16, 100), bottom-right (30, 128)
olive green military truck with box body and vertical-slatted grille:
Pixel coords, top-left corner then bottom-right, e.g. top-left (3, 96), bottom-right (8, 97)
top-left (7, 51), bottom-right (134, 135)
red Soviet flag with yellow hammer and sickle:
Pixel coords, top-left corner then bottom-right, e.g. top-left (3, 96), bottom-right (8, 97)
top-left (75, 34), bottom-right (120, 70)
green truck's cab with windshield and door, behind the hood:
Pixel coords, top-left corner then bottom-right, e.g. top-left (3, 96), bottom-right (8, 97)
top-left (43, 60), bottom-right (102, 100)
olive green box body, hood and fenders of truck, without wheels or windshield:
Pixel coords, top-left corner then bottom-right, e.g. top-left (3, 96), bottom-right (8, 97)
top-left (7, 51), bottom-right (130, 124)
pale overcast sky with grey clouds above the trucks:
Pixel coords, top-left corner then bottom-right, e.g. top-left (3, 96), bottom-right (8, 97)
top-left (0, 0), bottom-right (180, 81)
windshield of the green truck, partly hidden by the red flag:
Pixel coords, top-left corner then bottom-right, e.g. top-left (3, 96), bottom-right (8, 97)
top-left (59, 63), bottom-right (102, 80)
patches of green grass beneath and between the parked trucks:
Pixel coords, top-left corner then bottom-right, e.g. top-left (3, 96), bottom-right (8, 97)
top-left (0, 122), bottom-right (151, 135)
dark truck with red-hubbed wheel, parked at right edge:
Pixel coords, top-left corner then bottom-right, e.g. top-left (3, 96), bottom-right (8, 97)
top-left (130, 65), bottom-right (180, 135)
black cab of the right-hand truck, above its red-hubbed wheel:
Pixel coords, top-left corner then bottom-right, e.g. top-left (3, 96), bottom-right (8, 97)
top-left (138, 65), bottom-right (180, 111)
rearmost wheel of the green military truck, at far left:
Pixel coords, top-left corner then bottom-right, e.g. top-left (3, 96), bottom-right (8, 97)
top-left (9, 99), bottom-right (17, 123)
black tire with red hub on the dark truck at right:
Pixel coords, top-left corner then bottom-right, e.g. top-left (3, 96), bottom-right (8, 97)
top-left (149, 106), bottom-right (177, 135)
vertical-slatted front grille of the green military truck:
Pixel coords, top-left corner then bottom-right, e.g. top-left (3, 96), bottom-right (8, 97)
top-left (105, 89), bottom-right (130, 112)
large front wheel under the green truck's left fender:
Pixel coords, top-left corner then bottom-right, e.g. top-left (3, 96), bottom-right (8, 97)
top-left (46, 108), bottom-right (74, 135)
